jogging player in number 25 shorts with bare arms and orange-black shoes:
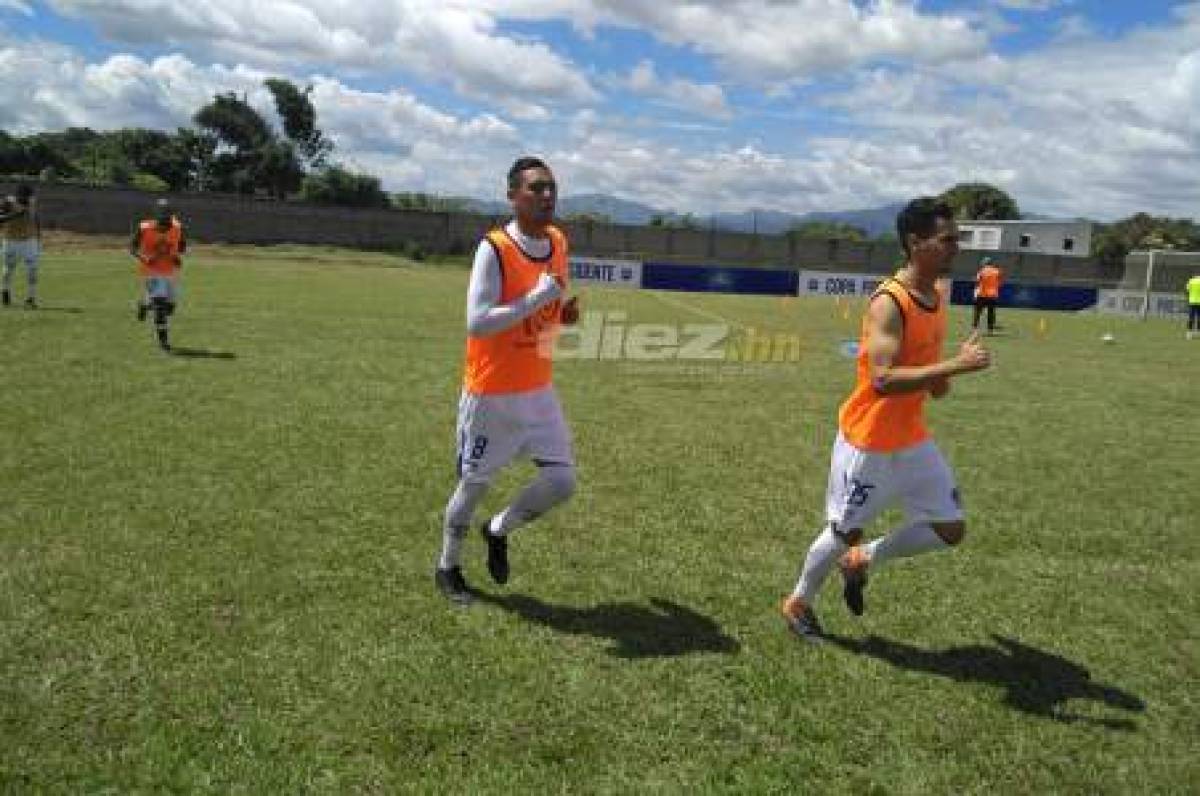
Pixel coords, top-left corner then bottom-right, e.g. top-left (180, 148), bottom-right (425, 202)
top-left (781, 197), bottom-right (991, 640)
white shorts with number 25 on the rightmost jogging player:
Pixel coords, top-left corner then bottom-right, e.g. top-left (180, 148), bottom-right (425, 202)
top-left (826, 431), bottom-right (962, 531)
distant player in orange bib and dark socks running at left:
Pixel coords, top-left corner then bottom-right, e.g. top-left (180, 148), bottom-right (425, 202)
top-left (130, 199), bottom-right (187, 352)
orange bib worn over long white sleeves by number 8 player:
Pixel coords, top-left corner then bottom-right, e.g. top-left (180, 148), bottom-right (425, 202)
top-left (463, 227), bottom-right (568, 395)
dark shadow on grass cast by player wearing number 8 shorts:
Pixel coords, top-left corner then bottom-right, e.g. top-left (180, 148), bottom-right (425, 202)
top-left (479, 593), bottom-right (740, 659)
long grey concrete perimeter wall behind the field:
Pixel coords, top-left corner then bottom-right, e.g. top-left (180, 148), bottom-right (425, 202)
top-left (14, 184), bottom-right (1122, 287)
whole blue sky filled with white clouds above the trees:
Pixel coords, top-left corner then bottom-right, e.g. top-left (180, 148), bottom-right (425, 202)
top-left (0, 0), bottom-right (1200, 219)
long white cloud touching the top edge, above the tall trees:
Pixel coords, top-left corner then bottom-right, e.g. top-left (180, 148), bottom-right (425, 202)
top-left (50, 0), bottom-right (596, 110)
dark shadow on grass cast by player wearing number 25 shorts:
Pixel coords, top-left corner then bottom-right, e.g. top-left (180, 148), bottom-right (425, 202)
top-left (827, 634), bottom-right (1146, 730)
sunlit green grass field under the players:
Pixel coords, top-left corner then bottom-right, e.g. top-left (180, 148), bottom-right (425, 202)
top-left (0, 238), bottom-right (1200, 794)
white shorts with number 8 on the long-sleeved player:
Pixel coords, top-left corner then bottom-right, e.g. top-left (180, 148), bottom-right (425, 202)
top-left (457, 387), bottom-right (575, 481)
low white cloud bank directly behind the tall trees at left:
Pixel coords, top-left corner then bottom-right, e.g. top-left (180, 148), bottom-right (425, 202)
top-left (0, 38), bottom-right (518, 199)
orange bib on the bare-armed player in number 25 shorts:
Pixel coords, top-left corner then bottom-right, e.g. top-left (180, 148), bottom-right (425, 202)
top-left (838, 279), bottom-right (946, 453)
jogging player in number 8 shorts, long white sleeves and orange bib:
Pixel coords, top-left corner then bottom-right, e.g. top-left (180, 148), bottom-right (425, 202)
top-left (434, 157), bottom-right (578, 604)
